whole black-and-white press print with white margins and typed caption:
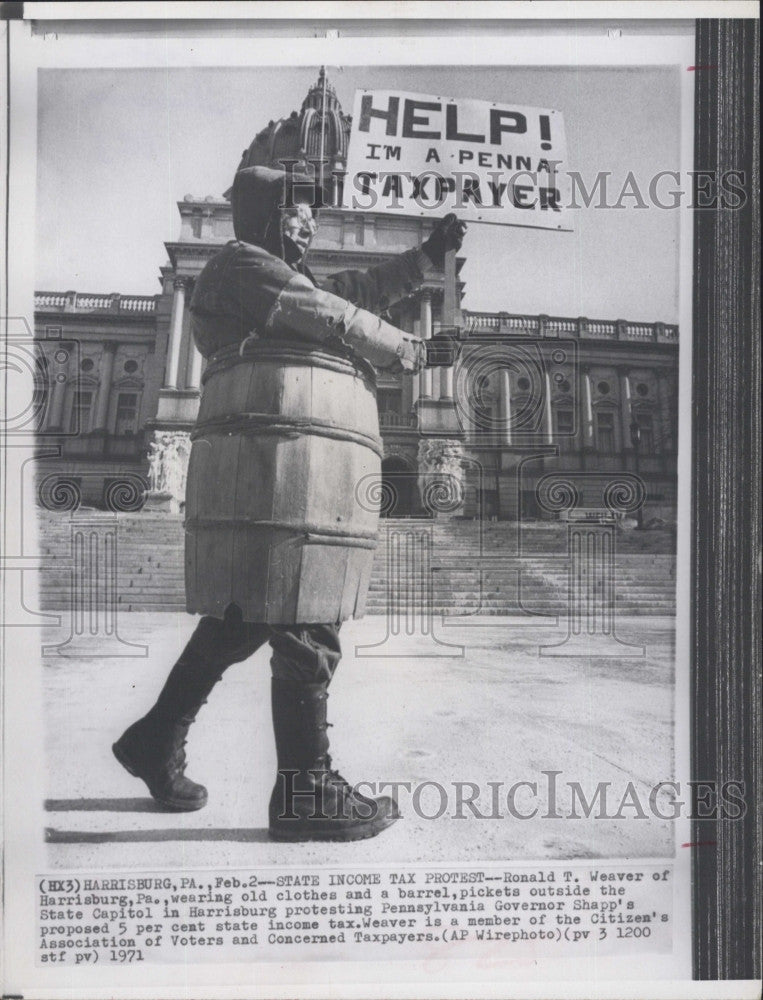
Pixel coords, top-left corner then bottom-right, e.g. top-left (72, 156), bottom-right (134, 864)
top-left (2, 4), bottom-right (757, 998)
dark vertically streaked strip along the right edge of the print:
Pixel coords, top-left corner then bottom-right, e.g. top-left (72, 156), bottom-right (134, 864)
top-left (691, 19), bottom-right (763, 979)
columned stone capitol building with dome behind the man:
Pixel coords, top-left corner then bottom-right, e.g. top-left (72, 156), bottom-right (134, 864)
top-left (35, 74), bottom-right (678, 523)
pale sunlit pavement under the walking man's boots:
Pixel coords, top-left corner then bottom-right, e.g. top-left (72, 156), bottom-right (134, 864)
top-left (43, 612), bottom-right (674, 870)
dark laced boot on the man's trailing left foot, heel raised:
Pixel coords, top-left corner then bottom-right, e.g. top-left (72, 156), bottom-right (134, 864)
top-left (112, 712), bottom-right (207, 812)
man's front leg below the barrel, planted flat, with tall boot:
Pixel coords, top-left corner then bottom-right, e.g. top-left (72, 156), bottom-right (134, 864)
top-left (269, 625), bottom-right (399, 841)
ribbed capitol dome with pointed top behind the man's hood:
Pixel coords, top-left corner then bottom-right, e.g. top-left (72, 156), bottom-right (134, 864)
top-left (226, 67), bottom-right (352, 200)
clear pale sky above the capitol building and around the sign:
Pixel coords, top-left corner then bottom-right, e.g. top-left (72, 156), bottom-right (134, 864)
top-left (36, 66), bottom-right (681, 323)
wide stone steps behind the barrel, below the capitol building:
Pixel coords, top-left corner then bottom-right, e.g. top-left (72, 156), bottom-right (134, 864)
top-left (39, 510), bottom-right (675, 615)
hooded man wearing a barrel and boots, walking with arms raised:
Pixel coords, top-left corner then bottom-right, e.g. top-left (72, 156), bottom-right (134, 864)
top-left (113, 167), bottom-right (465, 841)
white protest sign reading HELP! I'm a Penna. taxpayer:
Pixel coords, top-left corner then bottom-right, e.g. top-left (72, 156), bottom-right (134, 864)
top-left (343, 90), bottom-right (572, 230)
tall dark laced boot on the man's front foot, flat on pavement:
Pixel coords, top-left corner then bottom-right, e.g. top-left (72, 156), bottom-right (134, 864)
top-left (268, 678), bottom-right (400, 841)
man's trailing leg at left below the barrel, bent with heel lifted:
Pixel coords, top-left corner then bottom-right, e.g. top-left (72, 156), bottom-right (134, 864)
top-left (113, 608), bottom-right (269, 812)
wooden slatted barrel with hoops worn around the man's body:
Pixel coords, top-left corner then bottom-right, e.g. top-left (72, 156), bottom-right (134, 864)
top-left (185, 340), bottom-right (382, 625)
